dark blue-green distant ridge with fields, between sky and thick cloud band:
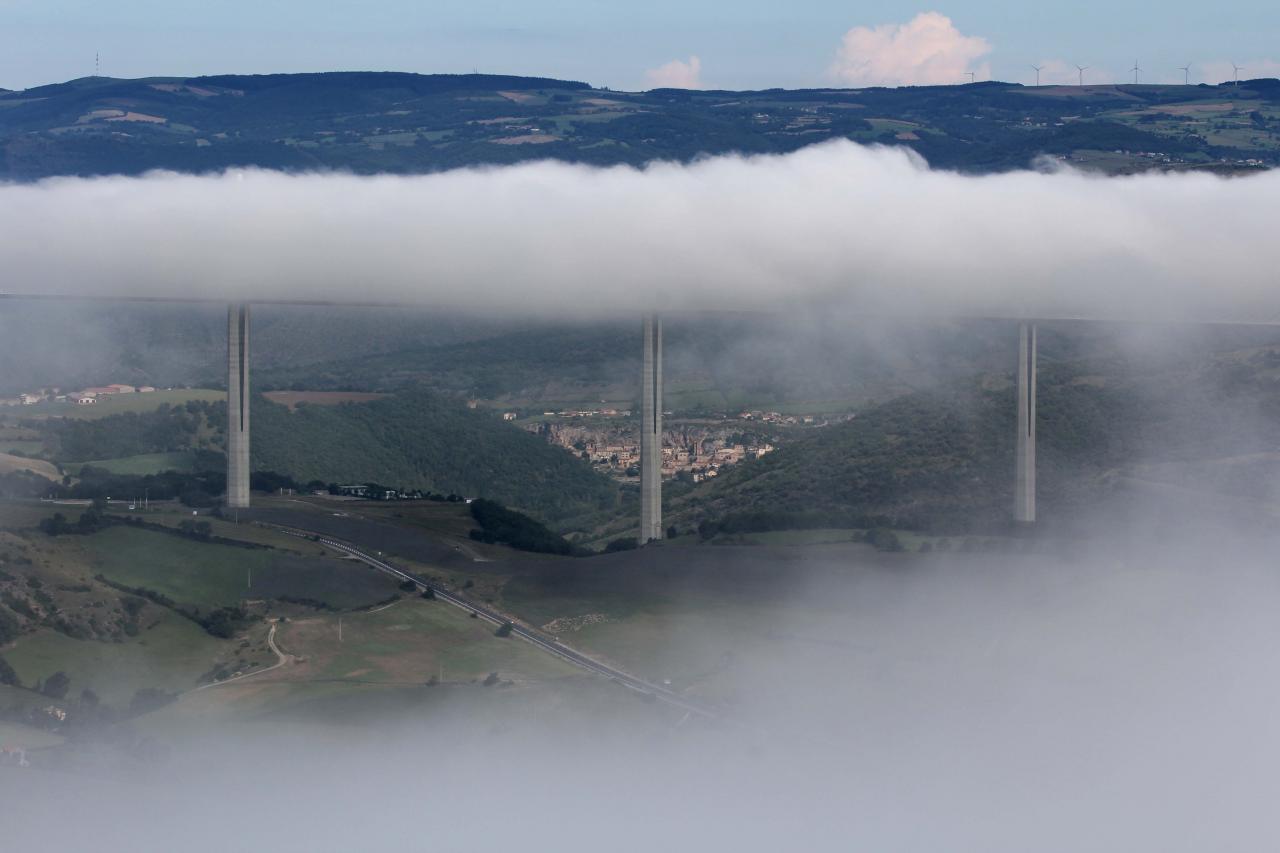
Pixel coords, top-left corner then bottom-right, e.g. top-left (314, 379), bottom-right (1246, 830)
top-left (0, 72), bottom-right (1280, 181)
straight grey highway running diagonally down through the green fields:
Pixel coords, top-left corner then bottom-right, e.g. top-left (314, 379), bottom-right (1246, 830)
top-left (257, 521), bottom-right (718, 717)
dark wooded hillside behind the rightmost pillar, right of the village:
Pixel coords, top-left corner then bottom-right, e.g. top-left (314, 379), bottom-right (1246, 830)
top-left (668, 347), bottom-right (1280, 532)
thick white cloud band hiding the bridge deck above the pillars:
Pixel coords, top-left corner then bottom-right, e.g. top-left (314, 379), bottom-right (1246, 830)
top-left (0, 141), bottom-right (1280, 321)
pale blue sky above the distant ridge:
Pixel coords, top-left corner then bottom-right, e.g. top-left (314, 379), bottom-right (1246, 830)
top-left (0, 0), bottom-right (1280, 88)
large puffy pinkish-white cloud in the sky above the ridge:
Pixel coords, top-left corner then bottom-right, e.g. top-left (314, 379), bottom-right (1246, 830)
top-left (829, 12), bottom-right (991, 86)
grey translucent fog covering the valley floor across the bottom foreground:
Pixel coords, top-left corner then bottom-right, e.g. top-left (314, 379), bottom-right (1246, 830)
top-left (0, 530), bottom-right (1280, 853)
